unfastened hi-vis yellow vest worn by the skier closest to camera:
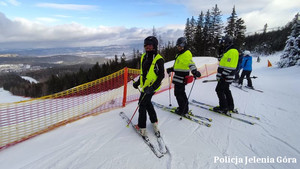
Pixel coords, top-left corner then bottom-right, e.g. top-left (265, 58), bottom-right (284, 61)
top-left (140, 53), bottom-right (164, 92)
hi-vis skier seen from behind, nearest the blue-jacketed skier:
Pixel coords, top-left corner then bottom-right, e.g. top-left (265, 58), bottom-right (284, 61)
top-left (213, 35), bottom-right (239, 116)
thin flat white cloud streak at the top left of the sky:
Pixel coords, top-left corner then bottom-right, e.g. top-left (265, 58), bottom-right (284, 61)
top-left (36, 3), bottom-right (97, 10)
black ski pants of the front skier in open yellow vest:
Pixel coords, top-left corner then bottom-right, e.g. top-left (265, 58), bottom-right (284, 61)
top-left (138, 92), bottom-right (157, 128)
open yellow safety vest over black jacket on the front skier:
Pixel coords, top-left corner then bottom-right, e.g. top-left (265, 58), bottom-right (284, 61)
top-left (140, 53), bottom-right (163, 92)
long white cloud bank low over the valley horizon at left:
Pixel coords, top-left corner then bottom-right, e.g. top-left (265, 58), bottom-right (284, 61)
top-left (0, 12), bottom-right (183, 48)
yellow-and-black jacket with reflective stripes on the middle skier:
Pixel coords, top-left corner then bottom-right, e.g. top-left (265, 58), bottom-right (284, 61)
top-left (172, 50), bottom-right (197, 84)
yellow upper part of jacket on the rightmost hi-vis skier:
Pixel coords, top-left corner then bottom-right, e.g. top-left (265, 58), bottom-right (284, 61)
top-left (219, 49), bottom-right (239, 70)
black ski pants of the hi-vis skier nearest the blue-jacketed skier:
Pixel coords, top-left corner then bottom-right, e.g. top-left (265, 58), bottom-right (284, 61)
top-left (216, 79), bottom-right (234, 110)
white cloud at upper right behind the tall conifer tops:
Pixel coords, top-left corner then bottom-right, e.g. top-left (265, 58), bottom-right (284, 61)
top-left (166, 0), bottom-right (300, 32)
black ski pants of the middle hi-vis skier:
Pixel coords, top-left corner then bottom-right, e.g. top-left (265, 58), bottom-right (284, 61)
top-left (174, 84), bottom-right (189, 114)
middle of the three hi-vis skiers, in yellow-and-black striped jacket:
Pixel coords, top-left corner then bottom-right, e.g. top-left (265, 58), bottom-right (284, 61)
top-left (167, 37), bottom-right (201, 116)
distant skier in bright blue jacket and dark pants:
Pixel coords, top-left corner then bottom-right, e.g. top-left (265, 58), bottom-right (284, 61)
top-left (239, 50), bottom-right (253, 89)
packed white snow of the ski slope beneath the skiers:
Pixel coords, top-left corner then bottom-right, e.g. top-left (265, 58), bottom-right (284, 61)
top-left (0, 53), bottom-right (300, 169)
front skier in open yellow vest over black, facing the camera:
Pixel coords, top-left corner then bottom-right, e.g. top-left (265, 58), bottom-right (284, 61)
top-left (133, 36), bottom-right (165, 137)
